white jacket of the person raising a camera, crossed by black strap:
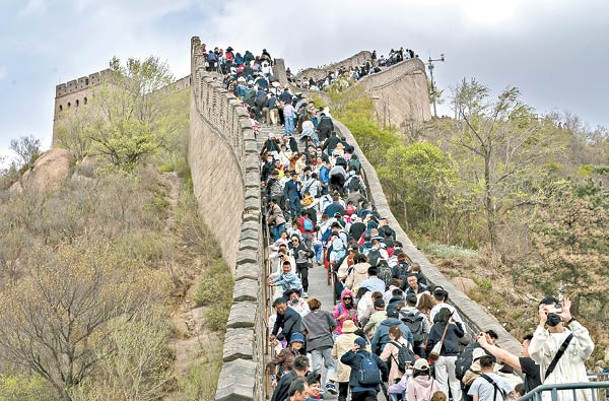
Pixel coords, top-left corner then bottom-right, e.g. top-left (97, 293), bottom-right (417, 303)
top-left (529, 320), bottom-right (594, 401)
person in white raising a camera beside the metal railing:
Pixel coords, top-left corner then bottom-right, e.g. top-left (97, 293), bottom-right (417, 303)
top-left (529, 297), bottom-right (594, 401)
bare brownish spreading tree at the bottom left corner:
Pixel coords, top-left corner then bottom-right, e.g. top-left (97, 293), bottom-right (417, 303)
top-left (0, 244), bottom-right (160, 399)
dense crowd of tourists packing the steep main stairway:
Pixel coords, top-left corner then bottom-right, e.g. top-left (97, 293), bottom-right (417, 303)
top-left (208, 43), bottom-right (594, 401)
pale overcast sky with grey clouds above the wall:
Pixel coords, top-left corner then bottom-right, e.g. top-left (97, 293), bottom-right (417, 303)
top-left (0, 0), bottom-right (609, 162)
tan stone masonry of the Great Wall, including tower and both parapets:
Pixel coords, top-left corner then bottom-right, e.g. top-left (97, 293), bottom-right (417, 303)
top-left (50, 37), bottom-right (520, 401)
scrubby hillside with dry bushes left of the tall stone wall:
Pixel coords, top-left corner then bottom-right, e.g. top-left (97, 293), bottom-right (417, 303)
top-left (0, 61), bottom-right (232, 400)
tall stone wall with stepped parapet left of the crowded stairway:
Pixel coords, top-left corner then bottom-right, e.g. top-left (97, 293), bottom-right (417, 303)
top-left (188, 37), bottom-right (266, 401)
